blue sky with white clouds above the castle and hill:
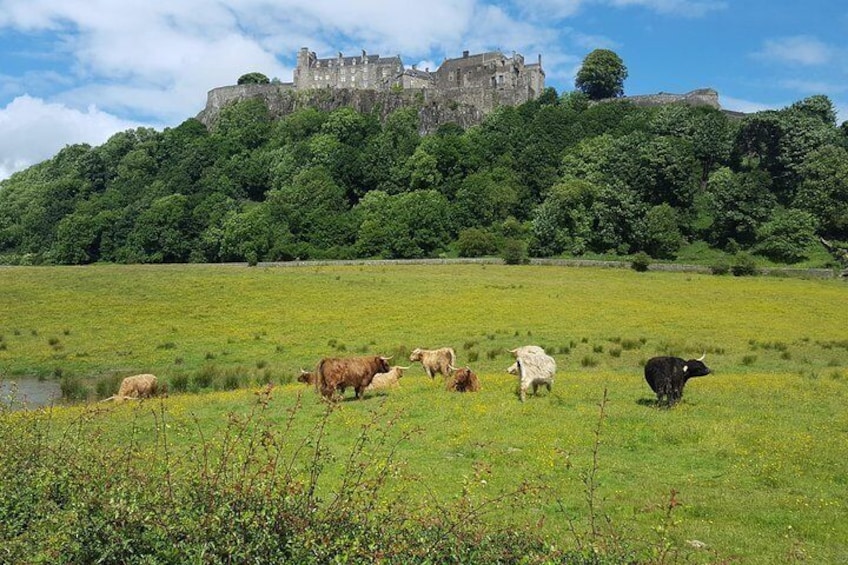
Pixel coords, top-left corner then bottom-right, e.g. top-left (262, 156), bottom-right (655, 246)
top-left (0, 0), bottom-right (848, 179)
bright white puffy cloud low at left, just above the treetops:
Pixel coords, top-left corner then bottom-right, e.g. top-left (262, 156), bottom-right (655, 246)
top-left (0, 96), bottom-right (141, 179)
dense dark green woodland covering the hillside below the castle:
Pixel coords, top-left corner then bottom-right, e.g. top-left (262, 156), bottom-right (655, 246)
top-left (0, 89), bottom-right (848, 264)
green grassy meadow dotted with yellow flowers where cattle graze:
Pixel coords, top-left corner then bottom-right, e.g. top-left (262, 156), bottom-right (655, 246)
top-left (0, 265), bottom-right (848, 564)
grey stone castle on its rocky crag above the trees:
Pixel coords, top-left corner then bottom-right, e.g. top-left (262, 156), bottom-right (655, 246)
top-left (197, 47), bottom-right (545, 134)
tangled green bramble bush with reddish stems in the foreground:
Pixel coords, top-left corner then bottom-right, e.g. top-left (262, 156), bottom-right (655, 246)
top-left (0, 387), bottom-right (712, 565)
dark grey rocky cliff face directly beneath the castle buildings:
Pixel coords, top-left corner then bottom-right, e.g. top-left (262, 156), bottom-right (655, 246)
top-left (197, 83), bottom-right (484, 135)
